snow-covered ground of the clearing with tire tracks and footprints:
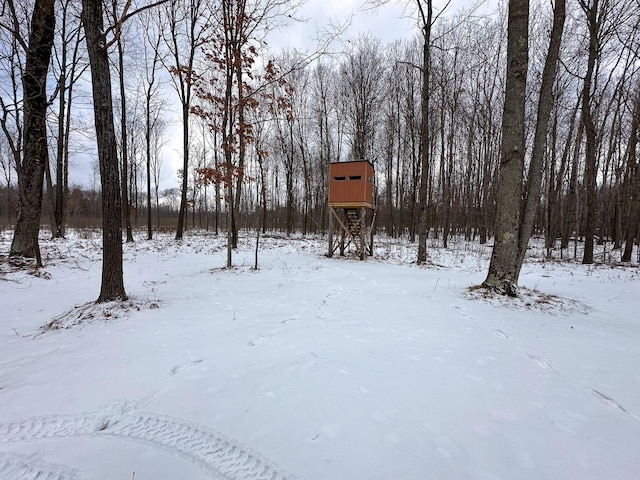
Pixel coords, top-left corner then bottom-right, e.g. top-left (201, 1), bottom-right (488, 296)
top-left (0, 231), bottom-right (640, 480)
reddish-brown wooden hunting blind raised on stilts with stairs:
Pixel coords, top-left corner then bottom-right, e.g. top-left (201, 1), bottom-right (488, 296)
top-left (328, 161), bottom-right (375, 260)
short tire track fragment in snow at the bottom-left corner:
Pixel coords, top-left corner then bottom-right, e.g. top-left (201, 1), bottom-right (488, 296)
top-left (0, 452), bottom-right (92, 480)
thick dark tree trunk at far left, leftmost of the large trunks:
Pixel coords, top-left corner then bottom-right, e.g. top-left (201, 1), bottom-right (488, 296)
top-left (9, 0), bottom-right (56, 266)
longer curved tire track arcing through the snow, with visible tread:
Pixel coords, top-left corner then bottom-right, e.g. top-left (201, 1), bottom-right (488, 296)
top-left (0, 410), bottom-right (294, 480)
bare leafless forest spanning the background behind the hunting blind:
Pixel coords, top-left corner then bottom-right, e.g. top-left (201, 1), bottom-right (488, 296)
top-left (0, 0), bottom-right (640, 260)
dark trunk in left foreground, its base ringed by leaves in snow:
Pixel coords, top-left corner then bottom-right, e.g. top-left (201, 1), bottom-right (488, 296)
top-left (82, 0), bottom-right (127, 303)
